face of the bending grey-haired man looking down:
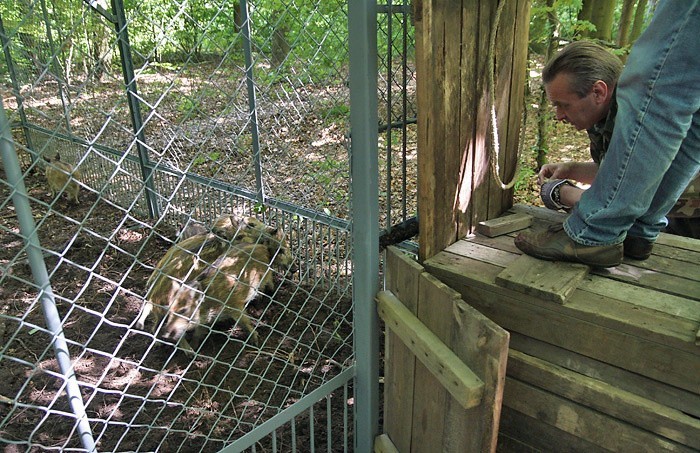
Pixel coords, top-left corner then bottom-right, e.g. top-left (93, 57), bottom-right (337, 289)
top-left (544, 73), bottom-right (610, 131)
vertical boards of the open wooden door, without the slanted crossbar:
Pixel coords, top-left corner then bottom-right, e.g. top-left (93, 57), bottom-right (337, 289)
top-left (384, 247), bottom-right (508, 452)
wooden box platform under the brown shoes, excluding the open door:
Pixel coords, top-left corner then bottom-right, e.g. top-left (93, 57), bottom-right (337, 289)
top-left (423, 206), bottom-right (700, 452)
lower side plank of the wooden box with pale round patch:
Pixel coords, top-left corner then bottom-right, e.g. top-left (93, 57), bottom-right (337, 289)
top-left (503, 377), bottom-right (696, 453)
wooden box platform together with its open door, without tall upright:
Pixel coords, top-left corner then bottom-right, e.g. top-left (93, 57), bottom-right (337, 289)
top-left (375, 206), bottom-right (700, 452)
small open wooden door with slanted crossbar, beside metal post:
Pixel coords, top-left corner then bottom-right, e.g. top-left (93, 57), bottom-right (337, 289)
top-left (376, 247), bottom-right (508, 452)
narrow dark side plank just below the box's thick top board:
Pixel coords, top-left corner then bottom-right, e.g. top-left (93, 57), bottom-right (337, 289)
top-left (510, 332), bottom-right (700, 418)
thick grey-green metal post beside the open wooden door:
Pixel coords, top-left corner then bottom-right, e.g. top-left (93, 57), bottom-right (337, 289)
top-left (348, 0), bottom-right (379, 452)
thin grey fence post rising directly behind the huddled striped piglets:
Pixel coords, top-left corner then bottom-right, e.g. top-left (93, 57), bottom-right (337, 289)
top-left (241, 0), bottom-right (265, 203)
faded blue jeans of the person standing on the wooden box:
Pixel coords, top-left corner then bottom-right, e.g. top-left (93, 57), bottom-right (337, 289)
top-left (564, 0), bottom-right (700, 245)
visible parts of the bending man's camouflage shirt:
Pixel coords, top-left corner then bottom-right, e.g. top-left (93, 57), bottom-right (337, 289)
top-left (586, 92), bottom-right (700, 218)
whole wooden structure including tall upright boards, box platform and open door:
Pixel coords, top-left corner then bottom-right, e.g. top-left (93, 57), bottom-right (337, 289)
top-left (375, 0), bottom-right (700, 453)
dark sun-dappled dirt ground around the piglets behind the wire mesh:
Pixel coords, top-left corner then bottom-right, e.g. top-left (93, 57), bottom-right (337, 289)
top-left (0, 169), bottom-right (352, 452)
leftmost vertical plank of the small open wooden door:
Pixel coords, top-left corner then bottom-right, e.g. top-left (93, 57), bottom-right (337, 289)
top-left (384, 246), bottom-right (423, 452)
